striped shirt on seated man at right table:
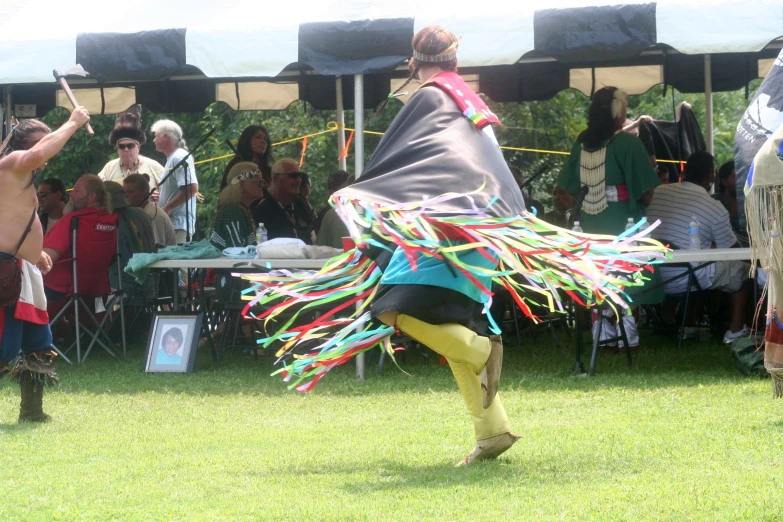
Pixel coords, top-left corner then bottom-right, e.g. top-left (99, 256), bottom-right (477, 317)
top-left (647, 181), bottom-right (737, 294)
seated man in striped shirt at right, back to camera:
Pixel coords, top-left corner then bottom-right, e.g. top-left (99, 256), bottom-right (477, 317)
top-left (647, 152), bottom-right (750, 344)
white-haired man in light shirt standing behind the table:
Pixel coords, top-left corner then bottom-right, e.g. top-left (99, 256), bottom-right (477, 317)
top-left (152, 120), bottom-right (198, 245)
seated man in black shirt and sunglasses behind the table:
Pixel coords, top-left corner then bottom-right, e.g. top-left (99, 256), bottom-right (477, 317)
top-left (252, 158), bottom-right (314, 245)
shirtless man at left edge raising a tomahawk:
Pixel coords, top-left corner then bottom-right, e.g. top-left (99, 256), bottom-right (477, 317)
top-left (0, 107), bottom-right (90, 422)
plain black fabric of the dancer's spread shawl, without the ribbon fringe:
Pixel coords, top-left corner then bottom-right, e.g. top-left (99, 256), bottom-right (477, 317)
top-left (337, 85), bottom-right (525, 217)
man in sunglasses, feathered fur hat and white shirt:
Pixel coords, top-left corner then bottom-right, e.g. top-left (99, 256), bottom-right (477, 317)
top-left (98, 104), bottom-right (164, 187)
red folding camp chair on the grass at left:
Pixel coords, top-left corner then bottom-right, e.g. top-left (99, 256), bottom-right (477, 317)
top-left (51, 212), bottom-right (126, 363)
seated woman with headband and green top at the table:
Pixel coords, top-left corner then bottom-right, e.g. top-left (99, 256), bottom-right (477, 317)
top-left (209, 161), bottom-right (269, 250)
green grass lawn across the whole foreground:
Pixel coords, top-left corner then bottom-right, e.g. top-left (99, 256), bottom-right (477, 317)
top-left (0, 333), bottom-right (783, 521)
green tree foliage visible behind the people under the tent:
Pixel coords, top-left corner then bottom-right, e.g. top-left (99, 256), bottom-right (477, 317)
top-left (38, 80), bottom-right (760, 237)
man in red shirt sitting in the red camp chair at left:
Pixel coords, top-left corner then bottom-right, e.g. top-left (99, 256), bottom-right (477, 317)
top-left (43, 174), bottom-right (116, 317)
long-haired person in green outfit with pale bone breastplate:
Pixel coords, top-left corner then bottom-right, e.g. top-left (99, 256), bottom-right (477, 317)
top-left (557, 87), bottom-right (664, 348)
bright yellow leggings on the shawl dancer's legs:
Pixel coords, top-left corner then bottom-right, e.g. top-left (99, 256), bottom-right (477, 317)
top-left (397, 314), bottom-right (511, 440)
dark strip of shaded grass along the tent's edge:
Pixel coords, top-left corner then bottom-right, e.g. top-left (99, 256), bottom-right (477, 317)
top-left (35, 324), bottom-right (760, 397)
